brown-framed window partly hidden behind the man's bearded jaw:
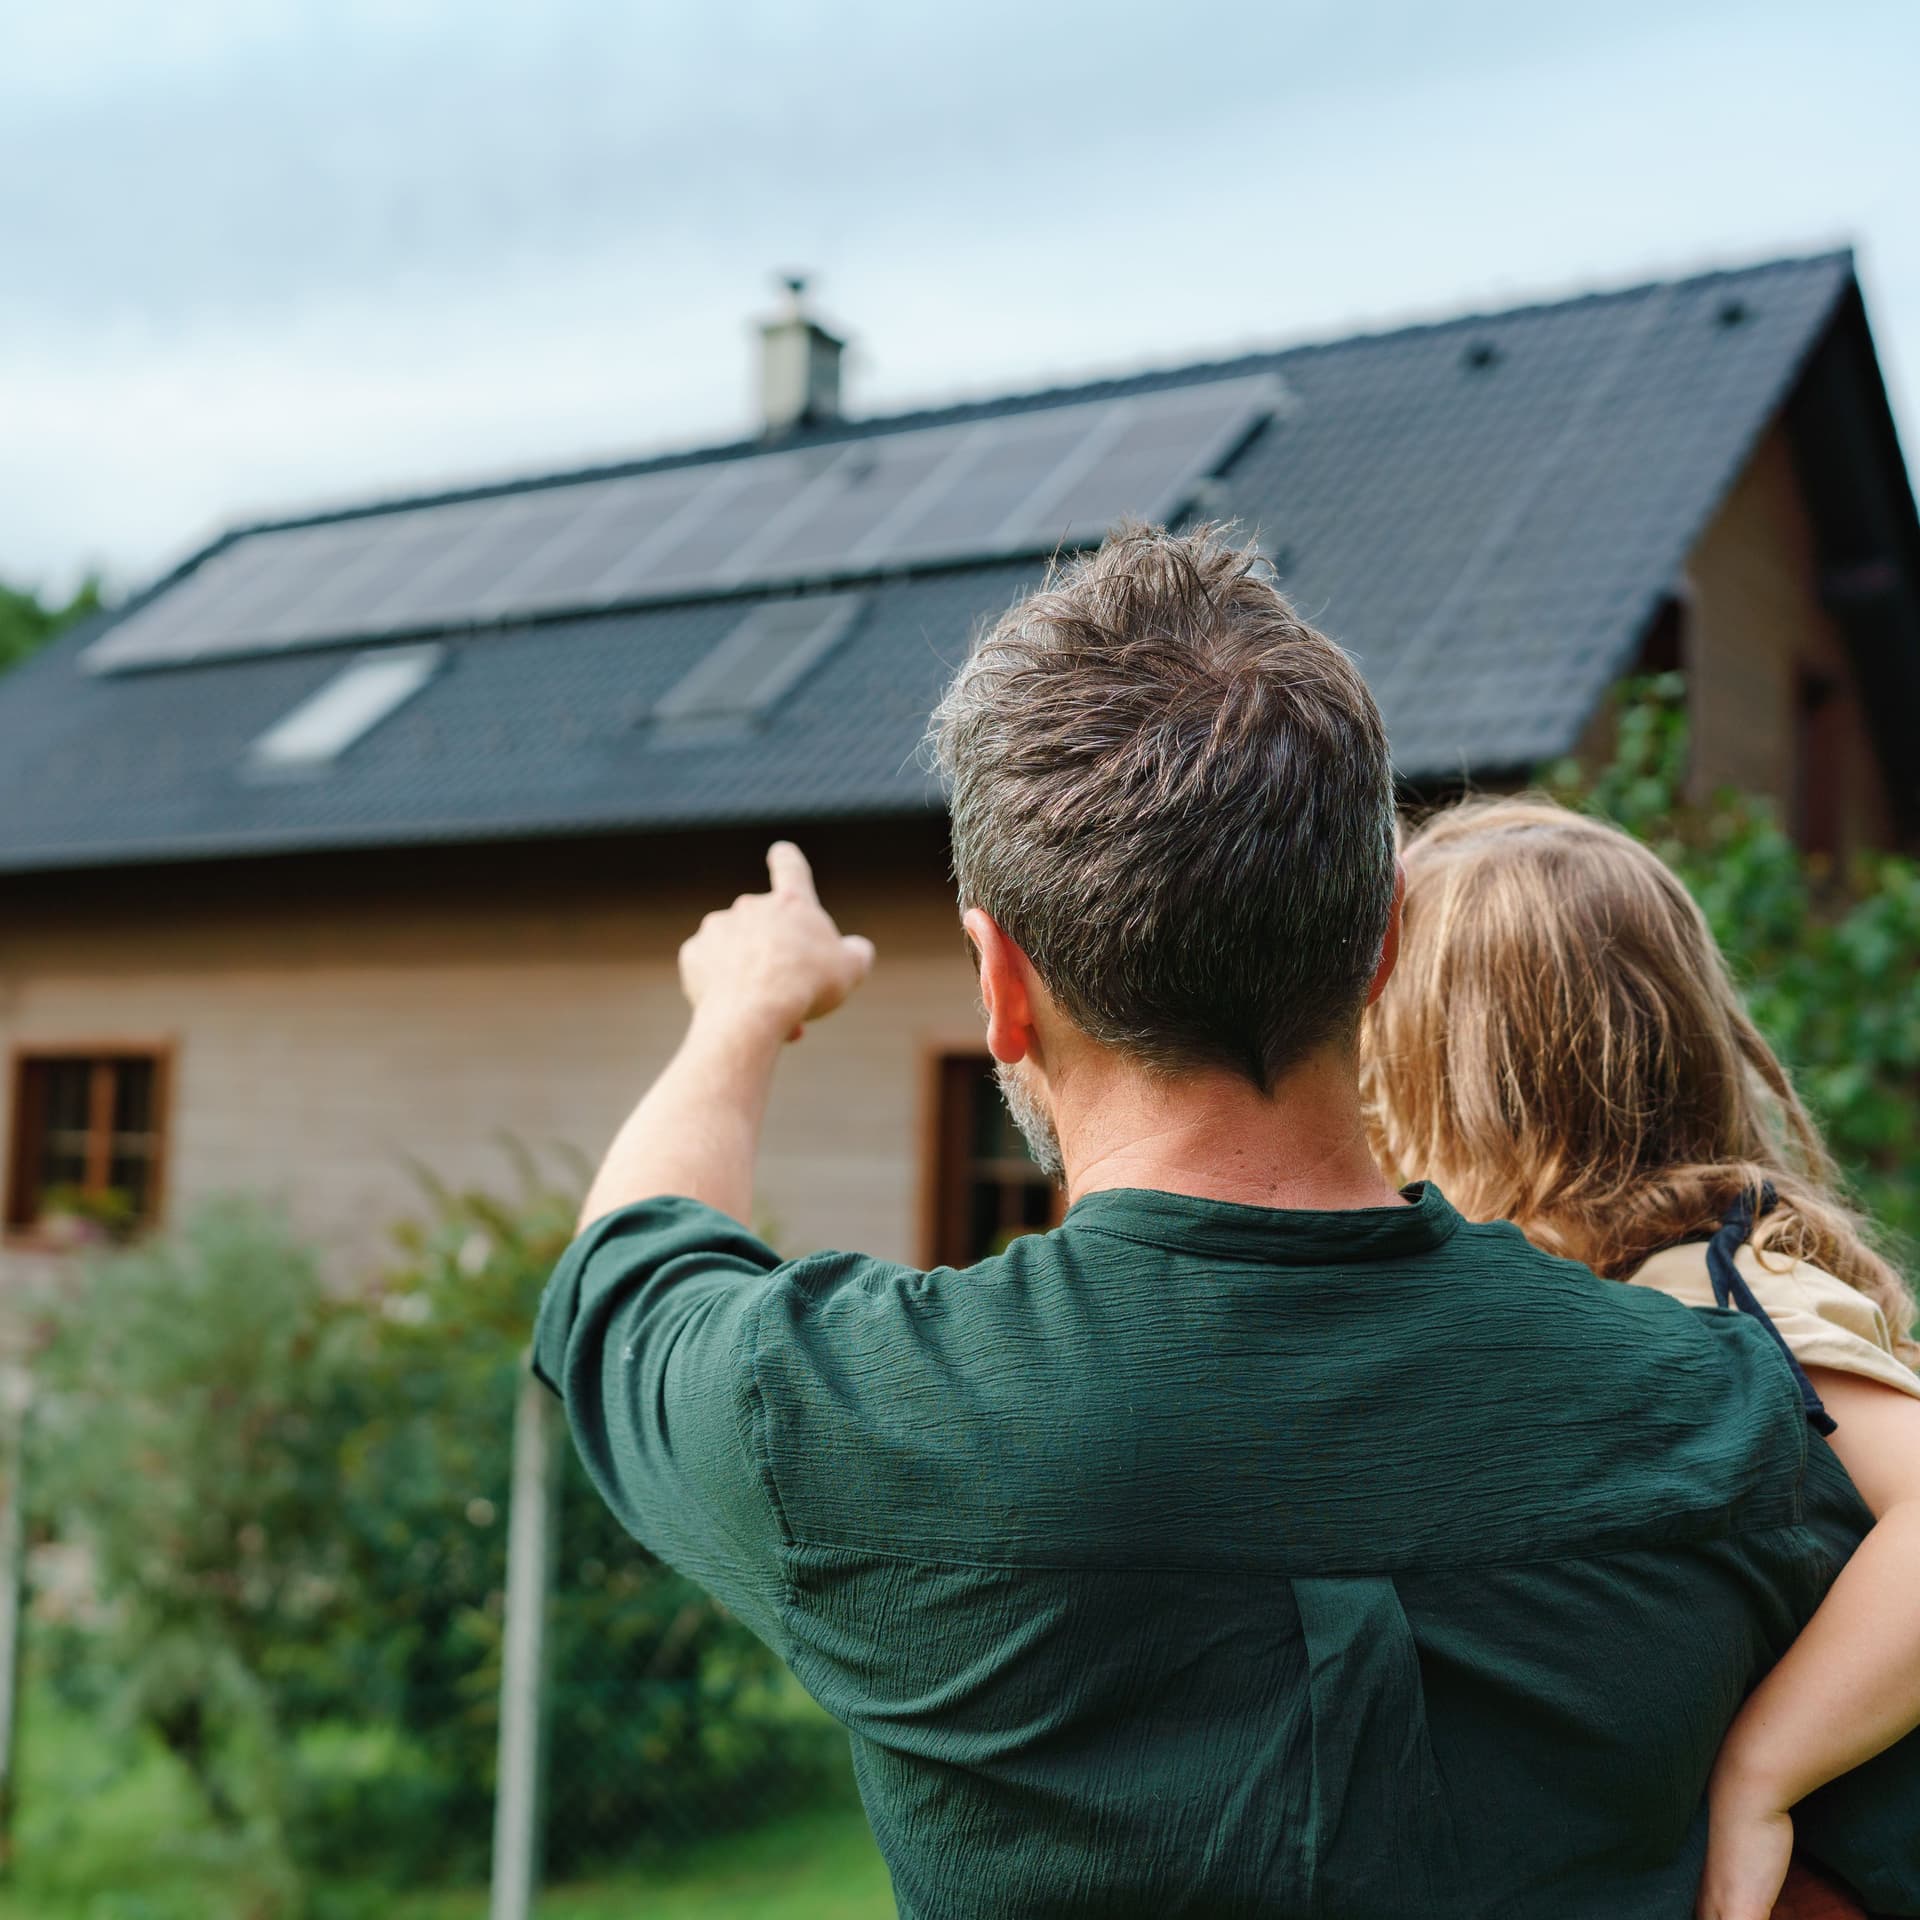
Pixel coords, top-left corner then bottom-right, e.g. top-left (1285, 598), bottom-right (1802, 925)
top-left (931, 1054), bottom-right (1060, 1267)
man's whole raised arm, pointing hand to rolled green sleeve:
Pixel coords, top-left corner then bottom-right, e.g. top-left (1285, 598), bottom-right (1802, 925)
top-left (534, 841), bottom-right (874, 1647)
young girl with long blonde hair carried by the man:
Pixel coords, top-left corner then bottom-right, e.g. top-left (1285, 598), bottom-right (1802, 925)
top-left (1363, 799), bottom-right (1920, 1920)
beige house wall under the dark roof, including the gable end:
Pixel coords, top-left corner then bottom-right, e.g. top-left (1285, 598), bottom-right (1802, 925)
top-left (0, 430), bottom-right (1889, 1283)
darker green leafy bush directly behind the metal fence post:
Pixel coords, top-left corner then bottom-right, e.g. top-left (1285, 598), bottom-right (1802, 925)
top-left (309, 1165), bottom-right (843, 1870)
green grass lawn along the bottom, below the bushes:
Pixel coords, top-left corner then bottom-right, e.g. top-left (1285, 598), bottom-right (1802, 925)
top-left (0, 1682), bottom-right (895, 1920)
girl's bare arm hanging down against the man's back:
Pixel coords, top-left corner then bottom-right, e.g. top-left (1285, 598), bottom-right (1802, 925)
top-left (1699, 1367), bottom-right (1920, 1920)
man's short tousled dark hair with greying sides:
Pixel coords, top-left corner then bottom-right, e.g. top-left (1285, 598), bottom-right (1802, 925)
top-left (931, 526), bottom-right (1394, 1091)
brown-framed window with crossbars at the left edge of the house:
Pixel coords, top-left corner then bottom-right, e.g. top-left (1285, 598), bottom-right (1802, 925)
top-left (6, 1050), bottom-right (165, 1235)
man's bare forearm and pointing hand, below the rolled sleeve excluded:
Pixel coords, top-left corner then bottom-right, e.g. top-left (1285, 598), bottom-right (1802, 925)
top-left (580, 841), bottom-right (874, 1229)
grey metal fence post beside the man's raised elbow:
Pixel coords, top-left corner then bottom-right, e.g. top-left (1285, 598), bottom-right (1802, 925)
top-left (490, 1373), bottom-right (563, 1920)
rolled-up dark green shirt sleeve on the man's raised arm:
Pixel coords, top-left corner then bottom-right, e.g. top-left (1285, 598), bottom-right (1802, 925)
top-left (534, 1200), bottom-right (785, 1651)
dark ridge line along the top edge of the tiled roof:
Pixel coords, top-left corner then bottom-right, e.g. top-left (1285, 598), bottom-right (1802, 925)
top-left (214, 246), bottom-right (1855, 549)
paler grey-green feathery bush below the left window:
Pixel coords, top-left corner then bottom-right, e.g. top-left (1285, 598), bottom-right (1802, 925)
top-left (29, 1202), bottom-right (353, 1912)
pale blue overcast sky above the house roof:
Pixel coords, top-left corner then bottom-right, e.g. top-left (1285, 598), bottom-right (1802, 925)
top-left (0, 0), bottom-right (1920, 588)
